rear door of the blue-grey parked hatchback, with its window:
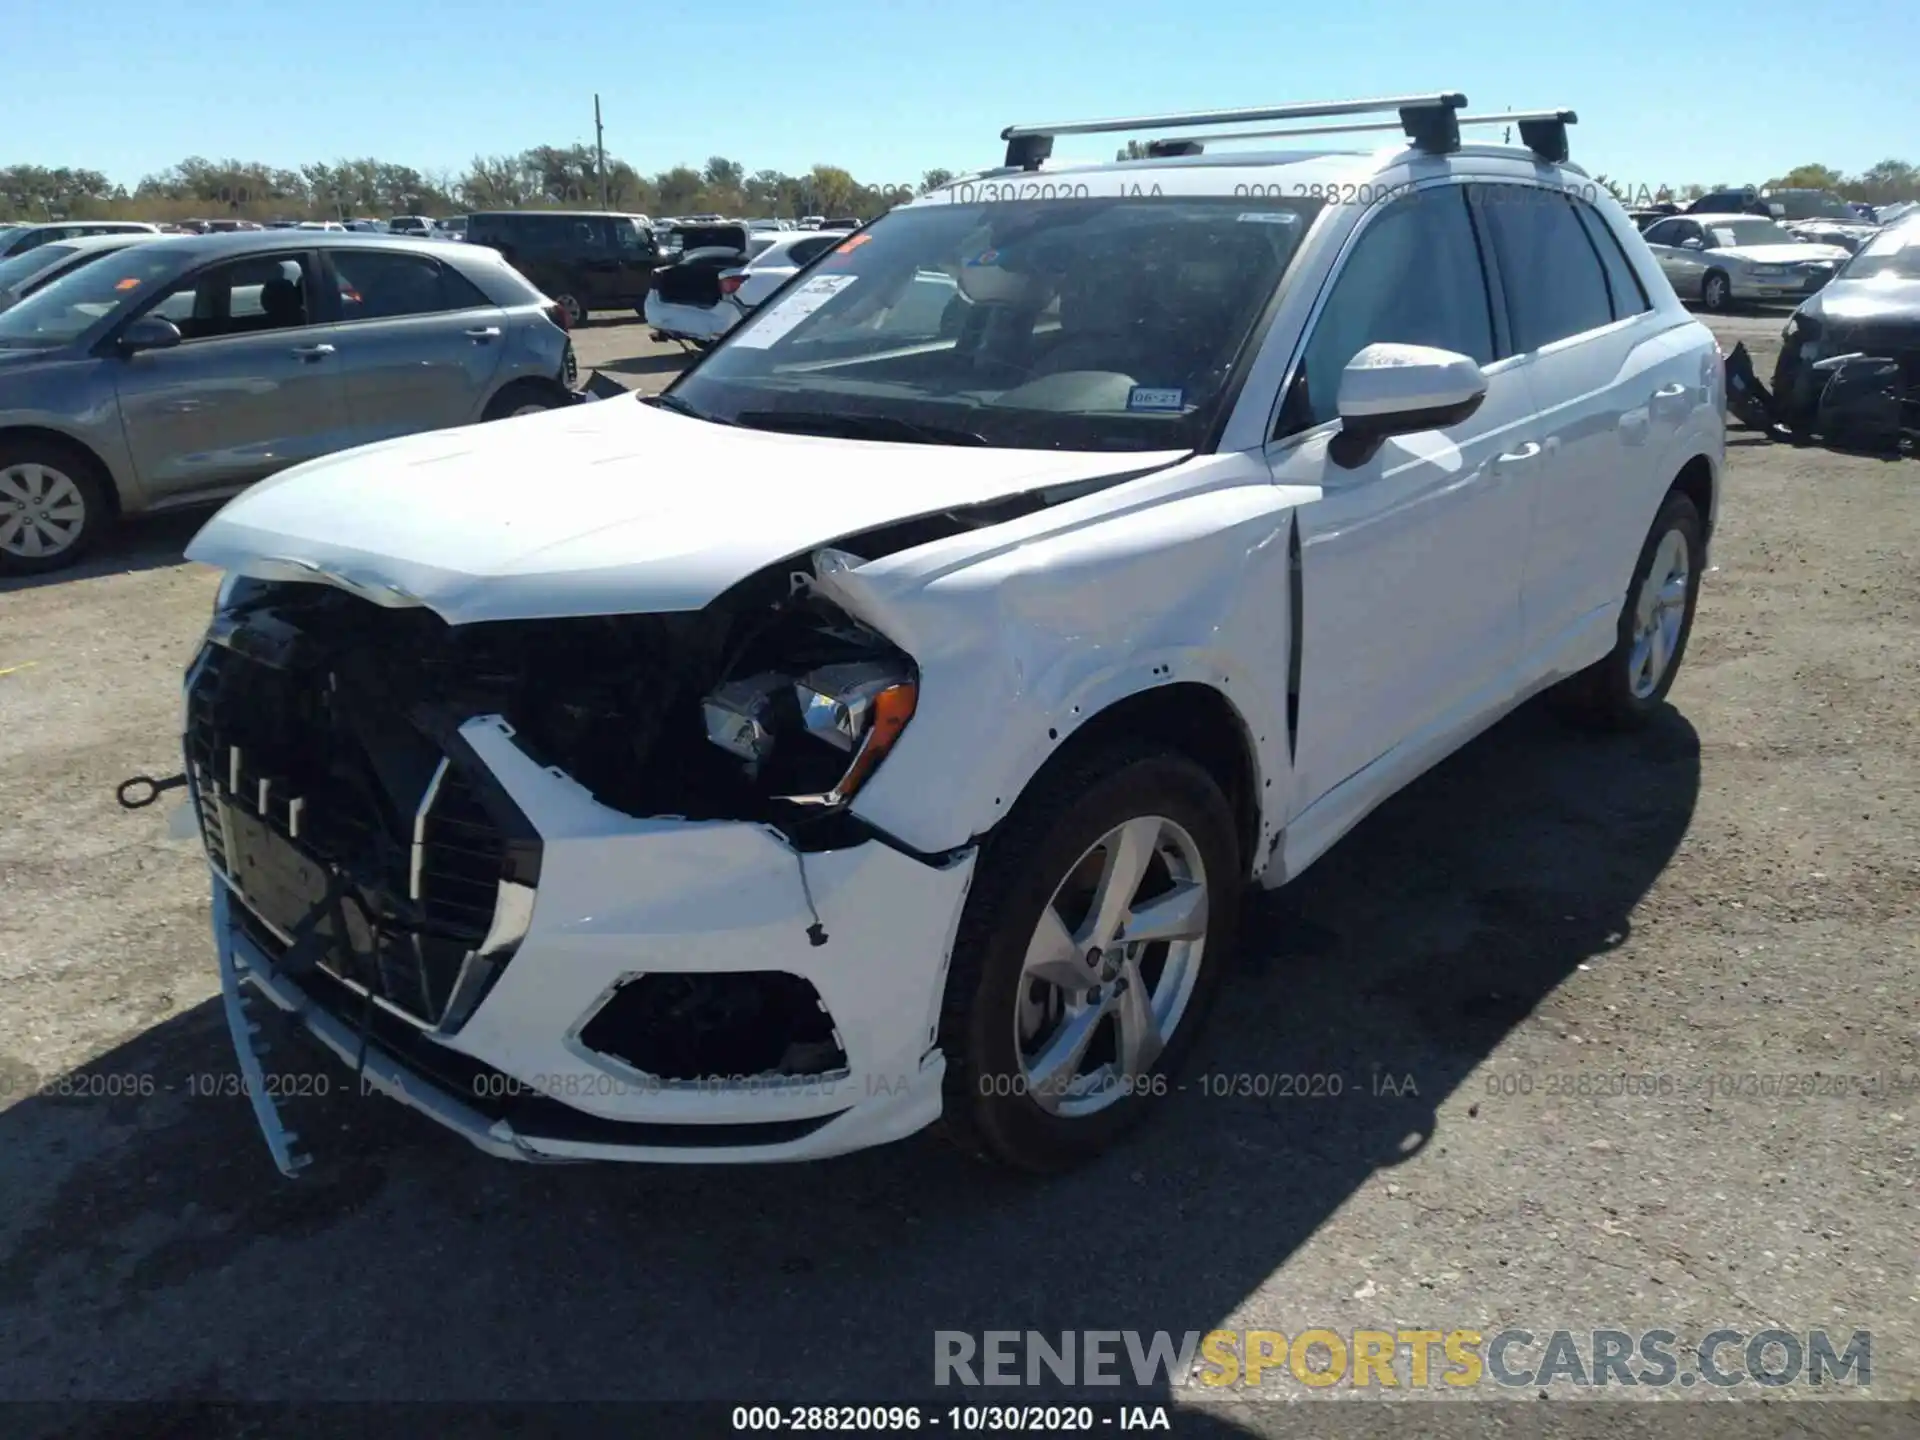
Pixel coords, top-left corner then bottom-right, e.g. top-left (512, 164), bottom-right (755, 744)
top-left (324, 246), bottom-right (507, 444)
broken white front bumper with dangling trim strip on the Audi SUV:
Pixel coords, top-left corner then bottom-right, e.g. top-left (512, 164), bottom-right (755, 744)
top-left (213, 716), bottom-right (973, 1173)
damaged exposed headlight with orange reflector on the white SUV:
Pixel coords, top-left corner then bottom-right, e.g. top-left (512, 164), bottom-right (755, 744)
top-left (701, 657), bottom-right (920, 806)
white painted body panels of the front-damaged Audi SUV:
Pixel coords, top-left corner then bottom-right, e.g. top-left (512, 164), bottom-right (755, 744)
top-left (188, 138), bottom-right (1724, 1160)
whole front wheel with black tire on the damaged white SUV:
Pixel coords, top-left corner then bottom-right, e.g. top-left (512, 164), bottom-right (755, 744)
top-left (941, 745), bottom-right (1244, 1173)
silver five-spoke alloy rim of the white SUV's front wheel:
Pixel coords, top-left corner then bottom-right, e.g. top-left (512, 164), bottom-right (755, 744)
top-left (1014, 816), bottom-right (1208, 1119)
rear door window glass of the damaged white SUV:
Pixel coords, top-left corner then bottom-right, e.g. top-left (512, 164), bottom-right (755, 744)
top-left (1476, 184), bottom-right (1613, 351)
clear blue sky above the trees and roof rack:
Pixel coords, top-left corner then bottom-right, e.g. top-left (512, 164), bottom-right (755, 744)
top-left (18, 0), bottom-right (1920, 186)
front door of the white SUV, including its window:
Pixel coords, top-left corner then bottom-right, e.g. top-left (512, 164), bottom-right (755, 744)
top-left (1269, 184), bottom-right (1540, 852)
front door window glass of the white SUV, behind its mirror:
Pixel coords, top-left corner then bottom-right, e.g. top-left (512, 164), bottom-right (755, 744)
top-left (1281, 186), bottom-right (1494, 434)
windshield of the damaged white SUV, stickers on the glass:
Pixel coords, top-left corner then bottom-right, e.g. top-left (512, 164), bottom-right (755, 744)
top-left (672, 184), bottom-right (1319, 451)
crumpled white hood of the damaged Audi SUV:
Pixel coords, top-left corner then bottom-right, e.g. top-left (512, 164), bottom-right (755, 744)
top-left (186, 399), bottom-right (1188, 624)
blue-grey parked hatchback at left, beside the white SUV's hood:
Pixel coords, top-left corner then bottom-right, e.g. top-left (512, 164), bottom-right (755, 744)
top-left (0, 230), bottom-right (576, 576)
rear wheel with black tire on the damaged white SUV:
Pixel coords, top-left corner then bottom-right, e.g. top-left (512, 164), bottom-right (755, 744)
top-left (1555, 490), bottom-right (1707, 730)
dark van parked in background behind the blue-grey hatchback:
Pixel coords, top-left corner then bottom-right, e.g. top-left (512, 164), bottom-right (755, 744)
top-left (467, 209), bottom-right (659, 326)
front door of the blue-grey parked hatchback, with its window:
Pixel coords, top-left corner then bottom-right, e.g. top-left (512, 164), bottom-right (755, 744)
top-left (115, 250), bottom-right (353, 501)
